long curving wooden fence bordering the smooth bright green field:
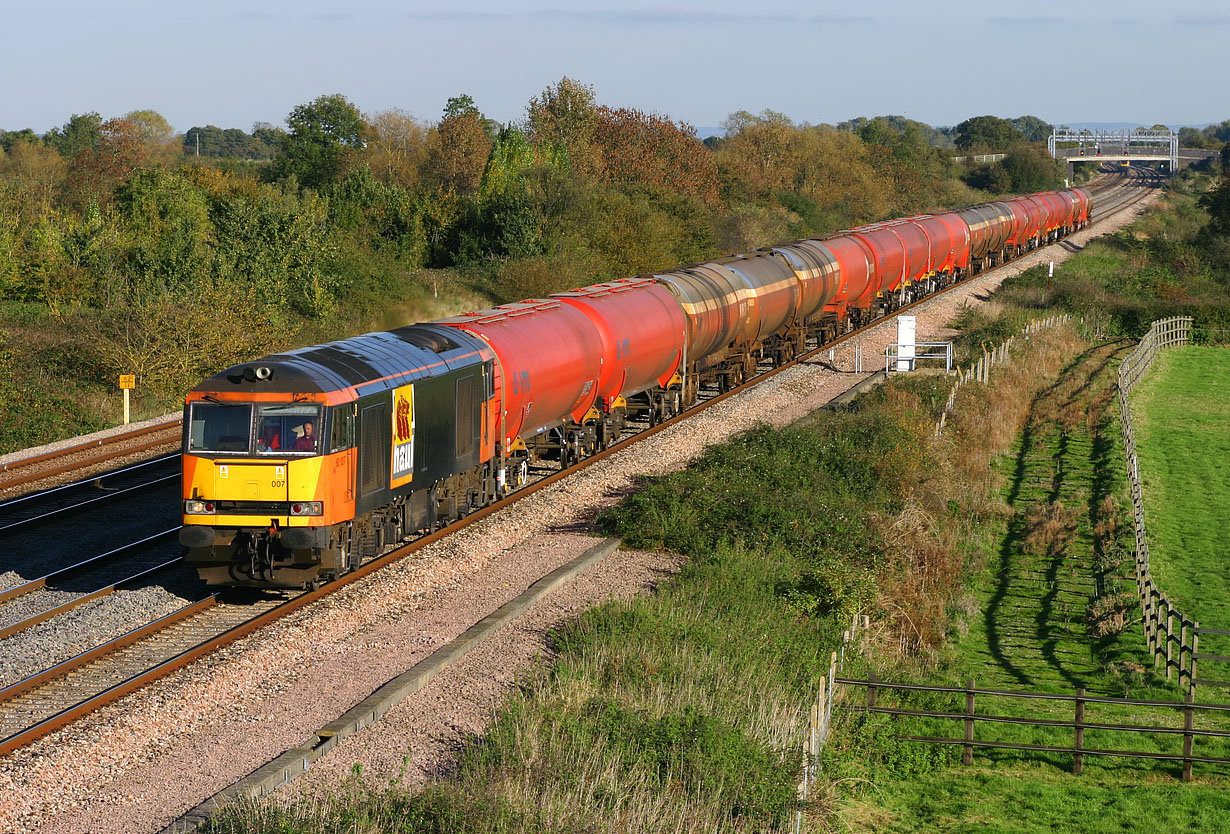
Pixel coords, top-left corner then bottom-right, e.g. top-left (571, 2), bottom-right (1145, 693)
top-left (1118, 316), bottom-right (1230, 690)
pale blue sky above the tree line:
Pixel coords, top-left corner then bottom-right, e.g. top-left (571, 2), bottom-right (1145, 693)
top-left (0, 0), bottom-right (1230, 133)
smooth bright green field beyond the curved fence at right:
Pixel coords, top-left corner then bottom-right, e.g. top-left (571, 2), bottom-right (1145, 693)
top-left (1132, 347), bottom-right (1230, 627)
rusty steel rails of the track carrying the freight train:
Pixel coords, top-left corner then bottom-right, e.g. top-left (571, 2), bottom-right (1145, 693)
top-left (0, 174), bottom-right (1144, 755)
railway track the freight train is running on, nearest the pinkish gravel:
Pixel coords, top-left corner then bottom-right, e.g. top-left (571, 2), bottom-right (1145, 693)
top-left (0, 173), bottom-right (1149, 754)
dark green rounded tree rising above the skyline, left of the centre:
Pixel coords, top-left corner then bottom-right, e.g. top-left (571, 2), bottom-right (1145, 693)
top-left (272, 93), bottom-right (364, 189)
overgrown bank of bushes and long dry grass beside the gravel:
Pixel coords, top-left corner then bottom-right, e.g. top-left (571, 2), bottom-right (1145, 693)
top-left (214, 319), bottom-right (1107, 832)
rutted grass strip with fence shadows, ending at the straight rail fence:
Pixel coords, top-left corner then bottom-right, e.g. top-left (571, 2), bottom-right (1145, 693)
top-left (953, 344), bottom-right (1146, 696)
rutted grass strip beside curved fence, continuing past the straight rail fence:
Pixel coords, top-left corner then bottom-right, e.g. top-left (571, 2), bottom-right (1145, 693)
top-left (827, 343), bottom-right (1230, 834)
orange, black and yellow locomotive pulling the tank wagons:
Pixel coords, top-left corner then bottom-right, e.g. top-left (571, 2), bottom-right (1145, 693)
top-left (180, 326), bottom-right (497, 588)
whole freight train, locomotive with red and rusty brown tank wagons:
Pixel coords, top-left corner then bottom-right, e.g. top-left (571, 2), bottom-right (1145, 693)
top-left (180, 188), bottom-right (1091, 588)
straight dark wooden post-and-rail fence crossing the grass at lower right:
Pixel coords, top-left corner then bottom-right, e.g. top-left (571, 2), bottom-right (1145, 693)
top-left (833, 677), bottom-right (1230, 781)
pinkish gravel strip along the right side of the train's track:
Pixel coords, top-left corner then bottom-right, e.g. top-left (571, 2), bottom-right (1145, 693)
top-left (0, 189), bottom-right (1156, 834)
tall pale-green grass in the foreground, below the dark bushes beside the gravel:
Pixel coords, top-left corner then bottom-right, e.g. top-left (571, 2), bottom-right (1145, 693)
top-left (207, 545), bottom-right (839, 834)
